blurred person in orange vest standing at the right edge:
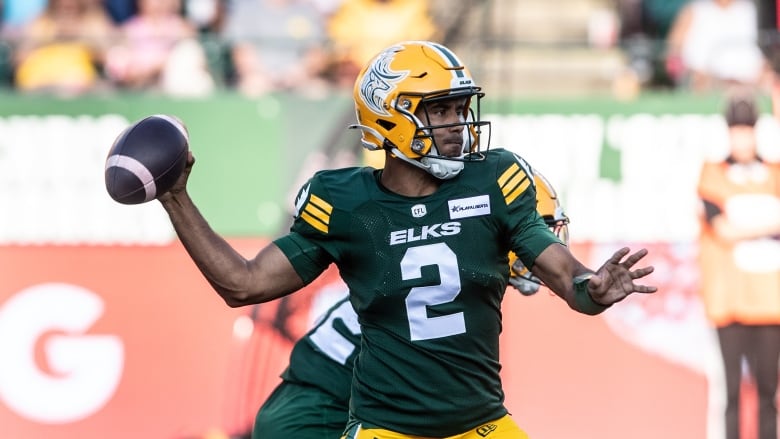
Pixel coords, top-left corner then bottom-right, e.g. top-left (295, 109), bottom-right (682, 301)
top-left (698, 90), bottom-right (780, 439)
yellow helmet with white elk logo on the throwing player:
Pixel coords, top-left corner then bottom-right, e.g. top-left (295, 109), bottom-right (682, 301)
top-left (350, 41), bottom-right (490, 179)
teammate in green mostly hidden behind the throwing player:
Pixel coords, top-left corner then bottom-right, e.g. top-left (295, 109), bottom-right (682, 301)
top-left (252, 172), bottom-right (569, 439)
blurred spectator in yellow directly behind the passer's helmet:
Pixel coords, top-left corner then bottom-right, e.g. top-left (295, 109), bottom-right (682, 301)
top-left (328, 0), bottom-right (437, 87)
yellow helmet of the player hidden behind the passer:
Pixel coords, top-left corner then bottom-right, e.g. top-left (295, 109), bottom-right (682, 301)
top-left (509, 172), bottom-right (569, 296)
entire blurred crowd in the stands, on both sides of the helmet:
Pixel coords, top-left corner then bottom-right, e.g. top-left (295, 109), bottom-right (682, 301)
top-left (0, 0), bottom-right (776, 97)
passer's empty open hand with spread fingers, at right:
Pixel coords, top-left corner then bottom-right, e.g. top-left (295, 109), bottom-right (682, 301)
top-left (588, 247), bottom-right (658, 305)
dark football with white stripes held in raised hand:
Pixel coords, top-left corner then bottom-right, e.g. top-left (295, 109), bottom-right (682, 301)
top-left (105, 114), bottom-right (189, 204)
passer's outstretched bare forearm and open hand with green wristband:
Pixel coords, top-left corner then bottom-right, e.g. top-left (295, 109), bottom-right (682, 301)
top-left (531, 244), bottom-right (657, 315)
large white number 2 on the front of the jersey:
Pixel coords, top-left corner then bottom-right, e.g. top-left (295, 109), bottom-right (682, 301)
top-left (401, 243), bottom-right (466, 341)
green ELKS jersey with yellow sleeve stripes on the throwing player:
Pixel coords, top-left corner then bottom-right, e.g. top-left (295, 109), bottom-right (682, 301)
top-left (275, 149), bottom-right (560, 436)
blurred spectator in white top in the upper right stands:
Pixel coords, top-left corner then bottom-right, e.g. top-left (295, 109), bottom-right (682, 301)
top-left (666, 0), bottom-right (768, 91)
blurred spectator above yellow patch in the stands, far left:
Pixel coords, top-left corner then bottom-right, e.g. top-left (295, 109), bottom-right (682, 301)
top-left (14, 0), bottom-right (115, 94)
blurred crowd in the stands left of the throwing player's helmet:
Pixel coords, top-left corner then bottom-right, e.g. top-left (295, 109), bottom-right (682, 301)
top-left (0, 0), bottom-right (436, 96)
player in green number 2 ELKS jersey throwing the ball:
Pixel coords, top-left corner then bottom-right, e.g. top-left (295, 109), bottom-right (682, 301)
top-left (159, 41), bottom-right (656, 439)
